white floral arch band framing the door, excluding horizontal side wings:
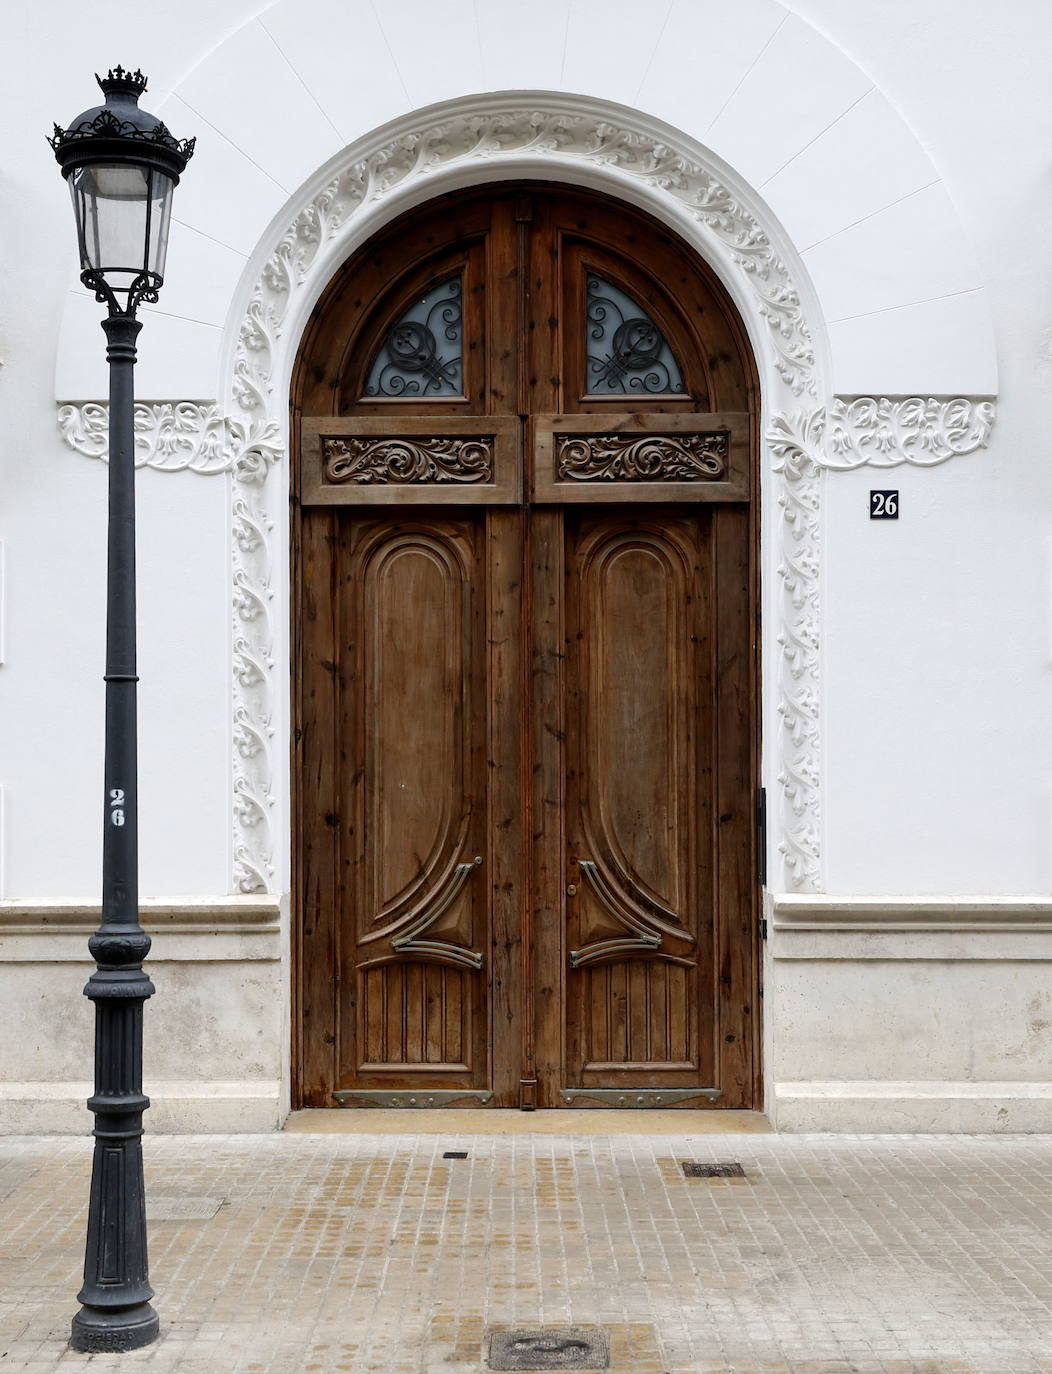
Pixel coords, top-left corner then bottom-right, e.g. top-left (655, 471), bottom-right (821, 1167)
top-left (222, 95), bottom-right (828, 890)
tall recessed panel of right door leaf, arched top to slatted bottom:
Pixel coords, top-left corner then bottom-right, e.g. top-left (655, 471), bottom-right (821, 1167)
top-left (564, 511), bottom-right (718, 1087)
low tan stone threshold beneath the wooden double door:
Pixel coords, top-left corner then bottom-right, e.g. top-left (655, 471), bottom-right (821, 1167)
top-left (283, 1107), bottom-right (773, 1135)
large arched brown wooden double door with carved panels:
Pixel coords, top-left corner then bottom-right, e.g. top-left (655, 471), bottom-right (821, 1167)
top-left (293, 184), bottom-right (759, 1107)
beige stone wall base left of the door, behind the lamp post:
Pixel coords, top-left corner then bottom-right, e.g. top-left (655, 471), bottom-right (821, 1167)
top-left (0, 897), bottom-right (290, 1135)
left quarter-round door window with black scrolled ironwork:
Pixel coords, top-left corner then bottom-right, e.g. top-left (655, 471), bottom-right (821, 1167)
top-left (365, 275), bottom-right (464, 397)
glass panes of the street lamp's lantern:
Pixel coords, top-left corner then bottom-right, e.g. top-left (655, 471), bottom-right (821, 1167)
top-left (69, 164), bottom-right (173, 306)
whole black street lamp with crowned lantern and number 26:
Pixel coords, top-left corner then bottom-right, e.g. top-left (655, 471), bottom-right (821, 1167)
top-left (49, 67), bottom-right (194, 1351)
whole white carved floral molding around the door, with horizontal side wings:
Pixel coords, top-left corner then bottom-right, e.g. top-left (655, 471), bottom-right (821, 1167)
top-left (60, 93), bottom-right (993, 893)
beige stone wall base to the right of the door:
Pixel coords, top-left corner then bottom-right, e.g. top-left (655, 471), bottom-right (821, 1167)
top-left (764, 896), bottom-right (1052, 1134)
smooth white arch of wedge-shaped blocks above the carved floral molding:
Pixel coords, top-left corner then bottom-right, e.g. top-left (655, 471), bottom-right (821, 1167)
top-left (56, 0), bottom-right (997, 400)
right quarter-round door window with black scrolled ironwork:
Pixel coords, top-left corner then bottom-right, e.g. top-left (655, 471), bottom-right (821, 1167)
top-left (585, 272), bottom-right (687, 396)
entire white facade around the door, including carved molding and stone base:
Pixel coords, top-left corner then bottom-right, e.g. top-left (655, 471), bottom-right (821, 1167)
top-left (0, 0), bottom-right (1052, 1131)
